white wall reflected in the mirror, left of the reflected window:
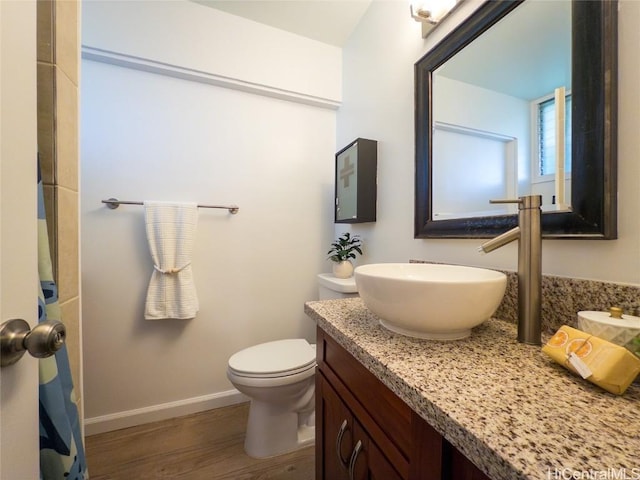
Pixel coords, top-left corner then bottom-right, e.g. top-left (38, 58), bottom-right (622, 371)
top-left (432, 75), bottom-right (531, 218)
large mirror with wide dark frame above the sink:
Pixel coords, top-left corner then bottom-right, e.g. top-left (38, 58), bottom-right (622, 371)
top-left (415, 0), bottom-right (618, 239)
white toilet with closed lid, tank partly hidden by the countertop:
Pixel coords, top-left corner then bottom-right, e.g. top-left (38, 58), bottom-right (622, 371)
top-left (227, 274), bottom-right (357, 458)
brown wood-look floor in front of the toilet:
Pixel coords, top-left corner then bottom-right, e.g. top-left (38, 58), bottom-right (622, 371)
top-left (85, 403), bottom-right (315, 480)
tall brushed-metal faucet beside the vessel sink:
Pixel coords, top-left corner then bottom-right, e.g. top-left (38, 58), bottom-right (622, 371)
top-left (478, 195), bottom-right (542, 345)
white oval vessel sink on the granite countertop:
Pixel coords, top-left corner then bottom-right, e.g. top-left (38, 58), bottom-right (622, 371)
top-left (354, 263), bottom-right (507, 340)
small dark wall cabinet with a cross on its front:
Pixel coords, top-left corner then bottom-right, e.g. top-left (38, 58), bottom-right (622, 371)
top-left (335, 138), bottom-right (378, 223)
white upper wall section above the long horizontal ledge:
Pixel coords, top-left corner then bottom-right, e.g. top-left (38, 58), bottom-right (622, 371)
top-left (82, 0), bottom-right (342, 100)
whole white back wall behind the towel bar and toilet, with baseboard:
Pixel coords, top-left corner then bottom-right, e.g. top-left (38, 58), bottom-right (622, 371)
top-left (81, 2), bottom-right (341, 433)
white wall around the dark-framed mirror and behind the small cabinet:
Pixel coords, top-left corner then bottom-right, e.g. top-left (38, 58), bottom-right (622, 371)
top-left (337, 0), bottom-right (640, 285)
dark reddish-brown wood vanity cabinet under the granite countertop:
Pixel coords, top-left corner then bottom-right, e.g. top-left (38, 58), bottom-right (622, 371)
top-left (316, 328), bottom-right (489, 480)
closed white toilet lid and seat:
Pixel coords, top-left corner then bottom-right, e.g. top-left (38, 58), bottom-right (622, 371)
top-left (229, 338), bottom-right (316, 376)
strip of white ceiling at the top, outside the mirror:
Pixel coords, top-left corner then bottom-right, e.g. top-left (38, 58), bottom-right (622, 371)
top-left (192, 0), bottom-right (371, 47)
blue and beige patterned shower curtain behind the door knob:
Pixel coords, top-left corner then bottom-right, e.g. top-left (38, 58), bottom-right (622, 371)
top-left (38, 160), bottom-right (89, 480)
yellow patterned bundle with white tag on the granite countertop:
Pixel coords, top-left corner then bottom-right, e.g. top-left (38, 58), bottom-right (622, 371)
top-left (542, 325), bottom-right (640, 395)
